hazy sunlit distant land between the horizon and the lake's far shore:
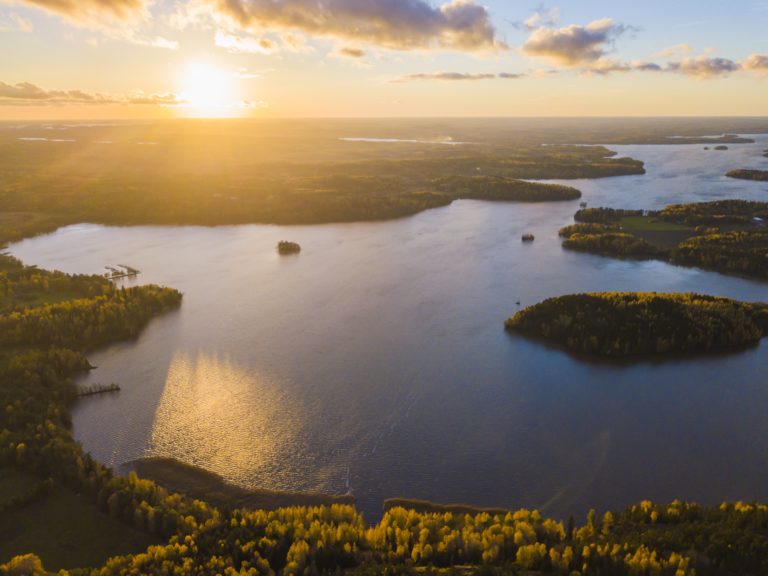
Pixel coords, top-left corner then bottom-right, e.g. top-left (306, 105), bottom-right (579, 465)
top-left (0, 118), bottom-right (768, 242)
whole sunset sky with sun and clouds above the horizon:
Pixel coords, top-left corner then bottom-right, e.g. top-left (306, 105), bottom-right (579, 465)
top-left (0, 0), bottom-right (768, 120)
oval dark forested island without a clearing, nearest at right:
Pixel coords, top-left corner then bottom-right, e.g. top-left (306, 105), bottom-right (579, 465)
top-left (506, 292), bottom-right (768, 357)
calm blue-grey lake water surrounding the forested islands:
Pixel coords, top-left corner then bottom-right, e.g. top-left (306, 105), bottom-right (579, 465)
top-left (11, 137), bottom-right (768, 518)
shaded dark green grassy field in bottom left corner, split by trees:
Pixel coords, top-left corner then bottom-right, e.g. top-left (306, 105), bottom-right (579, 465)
top-left (0, 469), bottom-right (159, 570)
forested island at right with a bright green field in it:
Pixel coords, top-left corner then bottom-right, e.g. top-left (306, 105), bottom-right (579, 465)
top-left (560, 200), bottom-right (768, 279)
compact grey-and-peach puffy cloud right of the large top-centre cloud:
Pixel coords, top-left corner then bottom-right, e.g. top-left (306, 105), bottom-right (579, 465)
top-left (522, 18), bottom-right (629, 68)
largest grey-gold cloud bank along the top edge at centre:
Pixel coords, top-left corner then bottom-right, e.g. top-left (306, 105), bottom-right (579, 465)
top-left (197, 0), bottom-right (506, 52)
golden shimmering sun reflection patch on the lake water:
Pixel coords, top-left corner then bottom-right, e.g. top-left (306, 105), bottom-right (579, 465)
top-left (147, 352), bottom-right (305, 488)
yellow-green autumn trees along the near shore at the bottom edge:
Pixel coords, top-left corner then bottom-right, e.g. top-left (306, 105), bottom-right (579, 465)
top-left (6, 501), bottom-right (768, 576)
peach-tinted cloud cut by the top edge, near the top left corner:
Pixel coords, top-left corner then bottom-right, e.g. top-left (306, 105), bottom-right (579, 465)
top-left (9, 0), bottom-right (150, 25)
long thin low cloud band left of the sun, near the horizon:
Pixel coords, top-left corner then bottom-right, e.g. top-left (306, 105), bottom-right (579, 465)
top-left (0, 82), bottom-right (184, 106)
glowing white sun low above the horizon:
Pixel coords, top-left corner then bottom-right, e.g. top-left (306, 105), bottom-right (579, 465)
top-left (181, 62), bottom-right (239, 118)
